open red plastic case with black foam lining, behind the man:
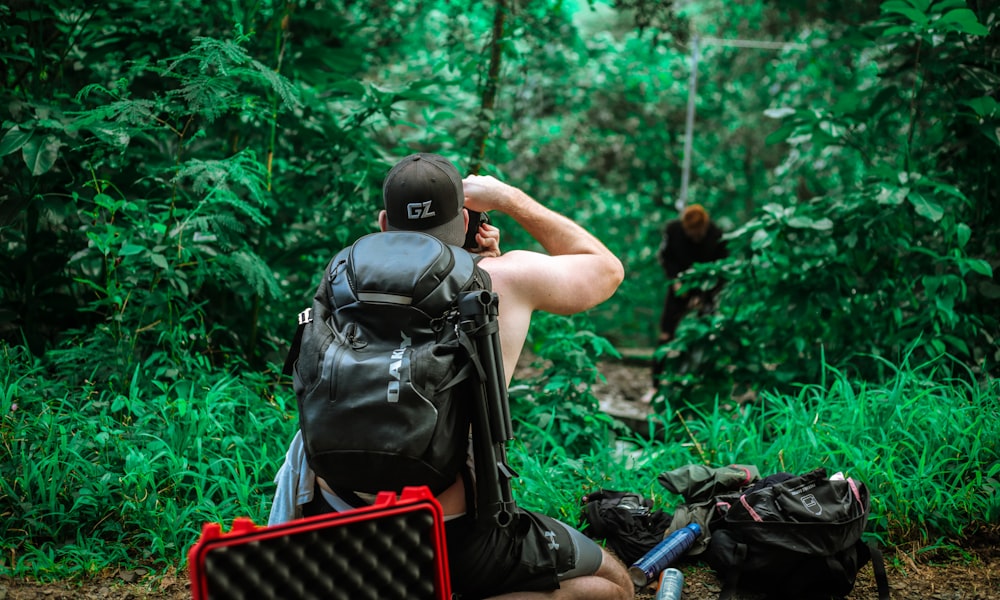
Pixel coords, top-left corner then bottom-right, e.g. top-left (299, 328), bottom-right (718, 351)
top-left (188, 487), bottom-right (451, 600)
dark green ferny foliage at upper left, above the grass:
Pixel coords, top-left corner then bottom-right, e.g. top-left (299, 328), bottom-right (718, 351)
top-left (0, 1), bottom-right (474, 373)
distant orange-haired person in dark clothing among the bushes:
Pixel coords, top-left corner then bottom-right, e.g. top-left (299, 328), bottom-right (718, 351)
top-left (656, 204), bottom-right (729, 344)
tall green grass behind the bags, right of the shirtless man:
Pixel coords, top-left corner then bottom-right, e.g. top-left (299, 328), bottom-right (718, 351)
top-left (512, 352), bottom-right (1000, 547)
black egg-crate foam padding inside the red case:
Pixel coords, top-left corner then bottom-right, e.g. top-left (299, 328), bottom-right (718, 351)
top-left (205, 511), bottom-right (440, 600)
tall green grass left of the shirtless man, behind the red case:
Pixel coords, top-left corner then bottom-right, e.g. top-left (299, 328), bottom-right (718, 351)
top-left (0, 346), bottom-right (295, 579)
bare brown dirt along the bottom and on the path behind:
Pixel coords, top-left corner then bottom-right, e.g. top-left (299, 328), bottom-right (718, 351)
top-left (0, 361), bottom-right (1000, 600)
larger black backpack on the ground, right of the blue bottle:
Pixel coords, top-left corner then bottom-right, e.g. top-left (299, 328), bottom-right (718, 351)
top-left (700, 468), bottom-right (889, 600)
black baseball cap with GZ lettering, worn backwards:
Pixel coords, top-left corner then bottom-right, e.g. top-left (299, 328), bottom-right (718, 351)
top-left (382, 152), bottom-right (465, 246)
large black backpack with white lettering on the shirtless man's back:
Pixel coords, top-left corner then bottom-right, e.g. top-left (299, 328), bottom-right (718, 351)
top-left (286, 231), bottom-right (491, 500)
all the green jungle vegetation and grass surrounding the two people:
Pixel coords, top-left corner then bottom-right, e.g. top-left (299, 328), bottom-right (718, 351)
top-left (0, 0), bottom-right (1000, 577)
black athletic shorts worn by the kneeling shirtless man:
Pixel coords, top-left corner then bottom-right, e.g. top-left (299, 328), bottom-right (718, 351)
top-left (302, 493), bottom-right (603, 600)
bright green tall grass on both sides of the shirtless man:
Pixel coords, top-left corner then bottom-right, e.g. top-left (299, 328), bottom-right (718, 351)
top-left (0, 348), bottom-right (1000, 579)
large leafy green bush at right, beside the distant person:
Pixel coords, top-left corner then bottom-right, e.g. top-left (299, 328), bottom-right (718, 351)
top-left (666, 2), bottom-right (1000, 402)
